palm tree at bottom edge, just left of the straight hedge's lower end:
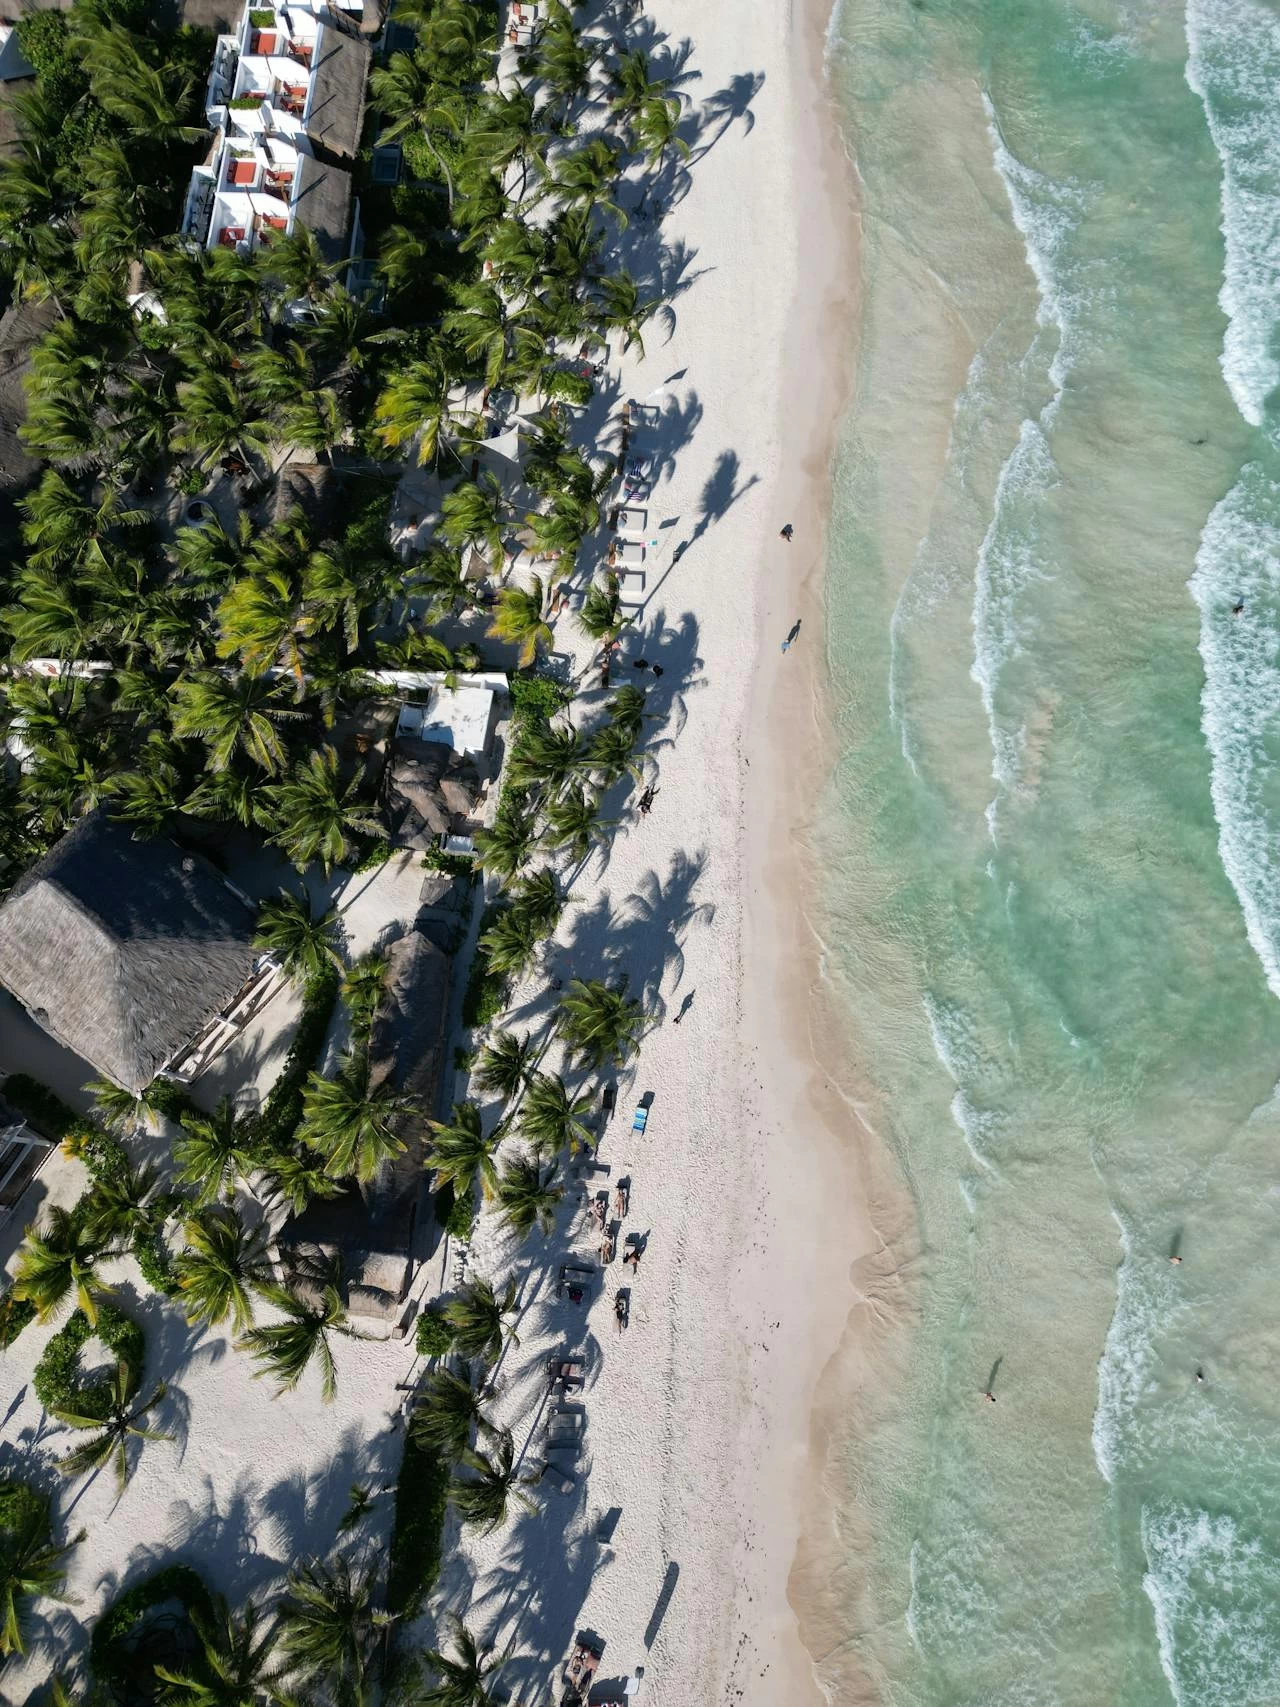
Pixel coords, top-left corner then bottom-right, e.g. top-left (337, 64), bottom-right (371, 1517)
top-left (278, 1553), bottom-right (391, 1707)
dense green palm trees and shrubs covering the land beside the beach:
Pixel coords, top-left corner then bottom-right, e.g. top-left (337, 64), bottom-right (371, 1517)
top-left (0, 0), bottom-right (684, 1679)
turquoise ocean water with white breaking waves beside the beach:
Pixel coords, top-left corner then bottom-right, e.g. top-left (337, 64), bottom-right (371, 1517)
top-left (819, 0), bottom-right (1280, 1707)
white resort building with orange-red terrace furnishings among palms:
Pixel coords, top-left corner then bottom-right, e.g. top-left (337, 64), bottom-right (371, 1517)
top-left (183, 0), bottom-right (370, 261)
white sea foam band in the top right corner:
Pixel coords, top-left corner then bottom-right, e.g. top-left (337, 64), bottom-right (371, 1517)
top-left (1186, 0), bottom-right (1280, 427)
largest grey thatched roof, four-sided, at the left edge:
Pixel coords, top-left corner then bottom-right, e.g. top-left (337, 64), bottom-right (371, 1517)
top-left (0, 811), bottom-right (256, 1092)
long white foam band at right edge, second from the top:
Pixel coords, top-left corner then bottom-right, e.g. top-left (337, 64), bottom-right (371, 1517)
top-left (1190, 463), bottom-right (1280, 997)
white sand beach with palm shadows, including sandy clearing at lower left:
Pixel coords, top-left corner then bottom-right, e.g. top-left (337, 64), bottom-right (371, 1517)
top-left (0, 0), bottom-right (870, 1707)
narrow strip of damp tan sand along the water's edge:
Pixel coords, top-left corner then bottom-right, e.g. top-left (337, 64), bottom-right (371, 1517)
top-left (744, 0), bottom-right (911, 1707)
